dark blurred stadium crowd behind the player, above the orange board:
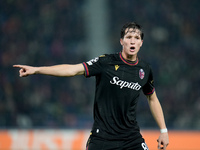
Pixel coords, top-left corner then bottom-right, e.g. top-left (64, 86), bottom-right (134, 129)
top-left (0, 0), bottom-right (200, 150)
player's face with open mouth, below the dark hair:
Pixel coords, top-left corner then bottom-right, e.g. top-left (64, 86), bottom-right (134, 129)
top-left (120, 29), bottom-right (143, 61)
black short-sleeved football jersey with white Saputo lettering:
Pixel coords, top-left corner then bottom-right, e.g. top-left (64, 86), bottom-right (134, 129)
top-left (83, 52), bottom-right (154, 140)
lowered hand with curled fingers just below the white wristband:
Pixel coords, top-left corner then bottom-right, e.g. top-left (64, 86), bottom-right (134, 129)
top-left (157, 133), bottom-right (169, 150)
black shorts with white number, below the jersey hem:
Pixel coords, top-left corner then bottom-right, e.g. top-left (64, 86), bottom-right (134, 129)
top-left (86, 135), bottom-right (149, 150)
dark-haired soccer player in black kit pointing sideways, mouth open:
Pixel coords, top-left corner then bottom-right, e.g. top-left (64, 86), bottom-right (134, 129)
top-left (14, 22), bottom-right (169, 150)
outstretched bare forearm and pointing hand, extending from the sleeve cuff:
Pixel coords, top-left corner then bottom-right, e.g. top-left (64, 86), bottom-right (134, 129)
top-left (13, 63), bottom-right (85, 77)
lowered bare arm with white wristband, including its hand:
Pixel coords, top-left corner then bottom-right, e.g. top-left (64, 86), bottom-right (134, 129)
top-left (147, 91), bottom-right (169, 150)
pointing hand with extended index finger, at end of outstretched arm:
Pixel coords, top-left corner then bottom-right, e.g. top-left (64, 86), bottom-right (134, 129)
top-left (13, 65), bottom-right (37, 77)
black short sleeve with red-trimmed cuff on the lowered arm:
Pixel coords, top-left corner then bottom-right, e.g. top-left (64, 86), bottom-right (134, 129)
top-left (142, 67), bottom-right (155, 95)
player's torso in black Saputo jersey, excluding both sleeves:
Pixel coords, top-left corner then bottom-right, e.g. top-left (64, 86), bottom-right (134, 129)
top-left (93, 55), bottom-right (148, 139)
